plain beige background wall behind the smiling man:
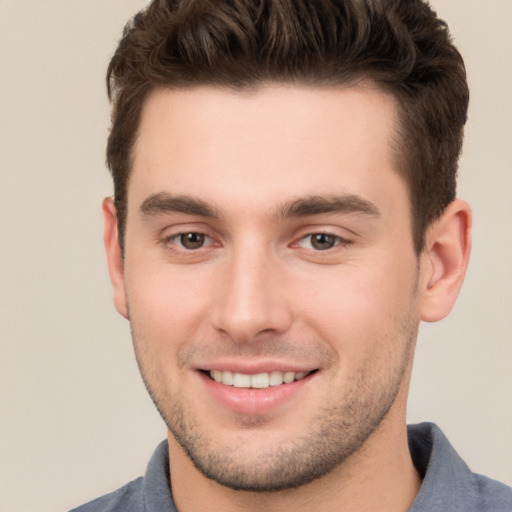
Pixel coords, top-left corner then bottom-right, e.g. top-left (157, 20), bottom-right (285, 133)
top-left (0, 0), bottom-right (512, 512)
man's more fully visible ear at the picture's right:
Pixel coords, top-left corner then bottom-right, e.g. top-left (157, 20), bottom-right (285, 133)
top-left (420, 199), bottom-right (471, 322)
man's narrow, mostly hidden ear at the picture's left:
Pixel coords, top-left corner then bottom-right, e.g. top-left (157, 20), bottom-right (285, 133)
top-left (102, 197), bottom-right (128, 318)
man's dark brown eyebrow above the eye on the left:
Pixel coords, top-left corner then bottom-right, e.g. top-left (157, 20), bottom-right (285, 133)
top-left (139, 192), bottom-right (221, 219)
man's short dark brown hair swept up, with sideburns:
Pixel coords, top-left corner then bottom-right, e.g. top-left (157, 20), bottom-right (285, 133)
top-left (107, 0), bottom-right (469, 253)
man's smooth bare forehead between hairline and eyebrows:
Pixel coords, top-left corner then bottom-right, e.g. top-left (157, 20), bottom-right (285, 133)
top-left (128, 84), bottom-right (404, 217)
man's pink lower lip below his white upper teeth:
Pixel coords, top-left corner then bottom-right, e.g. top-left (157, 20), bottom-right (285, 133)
top-left (199, 372), bottom-right (316, 415)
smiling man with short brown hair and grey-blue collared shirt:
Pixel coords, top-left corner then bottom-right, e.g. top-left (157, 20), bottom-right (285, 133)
top-left (71, 0), bottom-right (512, 512)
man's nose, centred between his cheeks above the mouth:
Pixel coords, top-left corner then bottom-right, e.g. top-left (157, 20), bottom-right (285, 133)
top-left (212, 246), bottom-right (293, 343)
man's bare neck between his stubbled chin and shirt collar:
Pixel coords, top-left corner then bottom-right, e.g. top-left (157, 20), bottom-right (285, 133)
top-left (169, 411), bottom-right (421, 512)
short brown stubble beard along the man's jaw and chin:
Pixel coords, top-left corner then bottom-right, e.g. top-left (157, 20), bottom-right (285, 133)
top-left (132, 314), bottom-right (418, 493)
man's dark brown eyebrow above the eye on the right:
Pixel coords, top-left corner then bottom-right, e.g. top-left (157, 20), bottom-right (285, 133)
top-left (273, 194), bottom-right (380, 221)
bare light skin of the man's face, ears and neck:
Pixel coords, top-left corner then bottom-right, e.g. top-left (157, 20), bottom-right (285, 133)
top-left (103, 85), bottom-right (470, 512)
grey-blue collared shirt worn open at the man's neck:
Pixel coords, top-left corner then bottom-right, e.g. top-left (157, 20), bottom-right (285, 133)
top-left (71, 423), bottom-right (512, 512)
